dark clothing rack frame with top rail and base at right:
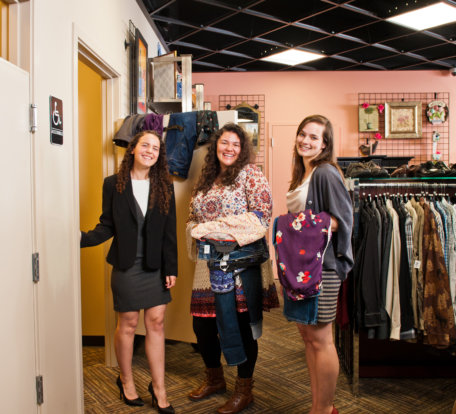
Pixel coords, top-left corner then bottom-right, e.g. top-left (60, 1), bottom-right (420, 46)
top-left (334, 177), bottom-right (456, 395)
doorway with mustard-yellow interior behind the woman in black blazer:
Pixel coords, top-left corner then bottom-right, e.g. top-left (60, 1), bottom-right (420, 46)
top-left (74, 34), bottom-right (120, 366)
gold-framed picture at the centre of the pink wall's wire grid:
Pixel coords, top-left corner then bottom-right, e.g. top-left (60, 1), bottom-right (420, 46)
top-left (385, 101), bottom-right (421, 138)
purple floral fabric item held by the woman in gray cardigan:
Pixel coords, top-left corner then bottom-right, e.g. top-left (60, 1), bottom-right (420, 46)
top-left (272, 210), bottom-right (331, 300)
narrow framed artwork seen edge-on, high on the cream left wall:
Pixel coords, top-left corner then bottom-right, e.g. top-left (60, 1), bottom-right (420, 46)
top-left (132, 28), bottom-right (148, 114)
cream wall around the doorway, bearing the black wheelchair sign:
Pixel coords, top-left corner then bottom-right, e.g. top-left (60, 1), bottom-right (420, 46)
top-left (30, 0), bottom-right (164, 414)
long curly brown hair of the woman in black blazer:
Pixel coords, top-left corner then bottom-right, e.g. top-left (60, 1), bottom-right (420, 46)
top-left (116, 130), bottom-right (173, 214)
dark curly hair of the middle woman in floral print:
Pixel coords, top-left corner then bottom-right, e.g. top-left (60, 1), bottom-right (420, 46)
top-left (193, 122), bottom-right (254, 195)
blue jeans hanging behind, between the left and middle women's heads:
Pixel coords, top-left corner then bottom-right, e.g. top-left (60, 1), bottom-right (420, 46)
top-left (166, 112), bottom-right (196, 178)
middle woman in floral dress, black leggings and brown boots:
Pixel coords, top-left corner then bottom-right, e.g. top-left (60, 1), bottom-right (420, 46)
top-left (188, 124), bottom-right (278, 414)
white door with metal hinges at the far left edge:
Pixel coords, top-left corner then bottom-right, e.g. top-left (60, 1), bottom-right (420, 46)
top-left (0, 58), bottom-right (38, 413)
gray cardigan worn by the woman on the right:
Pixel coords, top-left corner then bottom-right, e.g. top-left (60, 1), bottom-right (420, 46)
top-left (306, 163), bottom-right (353, 281)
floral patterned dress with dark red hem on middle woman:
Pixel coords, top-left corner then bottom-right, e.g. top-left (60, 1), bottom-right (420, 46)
top-left (188, 164), bottom-right (272, 317)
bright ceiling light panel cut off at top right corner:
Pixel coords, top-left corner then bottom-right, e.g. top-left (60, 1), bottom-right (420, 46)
top-left (386, 2), bottom-right (456, 30)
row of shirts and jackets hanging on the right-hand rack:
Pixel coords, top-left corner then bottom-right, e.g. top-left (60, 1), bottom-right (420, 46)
top-left (353, 194), bottom-right (456, 348)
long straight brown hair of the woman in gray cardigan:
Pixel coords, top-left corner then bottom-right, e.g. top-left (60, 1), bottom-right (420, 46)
top-left (288, 115), bottom-right (343, 191)
